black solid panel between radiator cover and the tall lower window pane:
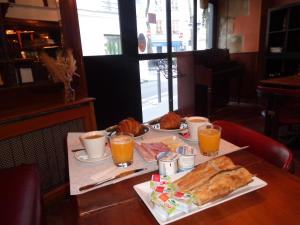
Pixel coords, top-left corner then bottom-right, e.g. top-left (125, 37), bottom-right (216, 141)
top-left (84, 55), bottom-right (142, 129)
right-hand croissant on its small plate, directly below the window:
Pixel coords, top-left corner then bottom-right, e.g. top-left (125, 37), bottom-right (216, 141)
top-left (148, 112), bottom-right (187, 133)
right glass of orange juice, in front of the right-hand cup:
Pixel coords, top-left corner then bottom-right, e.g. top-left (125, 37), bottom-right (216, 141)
top-left (198, 124), bottom-right (221, 156)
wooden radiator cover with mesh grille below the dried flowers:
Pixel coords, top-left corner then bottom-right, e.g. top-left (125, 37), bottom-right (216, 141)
top-left (0, 98), bottom-right (97, 201)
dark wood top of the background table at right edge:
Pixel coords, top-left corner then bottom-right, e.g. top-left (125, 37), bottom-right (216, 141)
top-left (260, 74), bottom-right (300, 88)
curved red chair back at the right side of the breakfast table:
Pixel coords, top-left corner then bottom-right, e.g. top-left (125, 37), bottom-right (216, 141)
top-left (214, 120), bottom-right (294, 172)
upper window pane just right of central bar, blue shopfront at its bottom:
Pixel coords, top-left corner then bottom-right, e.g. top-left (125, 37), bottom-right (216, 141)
top-left (171, 0), bottom-right (194, 52)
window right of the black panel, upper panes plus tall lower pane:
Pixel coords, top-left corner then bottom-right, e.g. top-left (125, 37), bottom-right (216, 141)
top-left (136, 0), bottom-right (212, 122)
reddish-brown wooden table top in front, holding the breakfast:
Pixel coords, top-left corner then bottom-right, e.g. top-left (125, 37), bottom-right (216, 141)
top-left (75, 150), bottom-right (300, 225)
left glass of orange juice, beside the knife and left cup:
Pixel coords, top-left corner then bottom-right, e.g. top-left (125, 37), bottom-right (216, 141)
top-left (109, 133), bottom-right (134, 167)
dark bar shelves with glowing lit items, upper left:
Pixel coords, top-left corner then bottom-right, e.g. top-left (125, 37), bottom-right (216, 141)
top-left (0, 17), bottom-right (61, 88)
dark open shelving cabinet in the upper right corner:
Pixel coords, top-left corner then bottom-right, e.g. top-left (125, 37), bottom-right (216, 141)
top-left (264, 3), bottom-right (300, 79)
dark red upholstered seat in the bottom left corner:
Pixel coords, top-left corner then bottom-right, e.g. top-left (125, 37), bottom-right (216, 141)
top-left (0, 165), bottom-right (41, 225)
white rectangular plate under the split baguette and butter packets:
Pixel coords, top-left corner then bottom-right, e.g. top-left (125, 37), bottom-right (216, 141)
top-left (133, 172), bottom-right (267, 224)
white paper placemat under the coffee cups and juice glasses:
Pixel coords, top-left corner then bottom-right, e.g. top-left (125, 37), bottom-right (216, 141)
top-left (67, 129), bottom-right (246, 195)
